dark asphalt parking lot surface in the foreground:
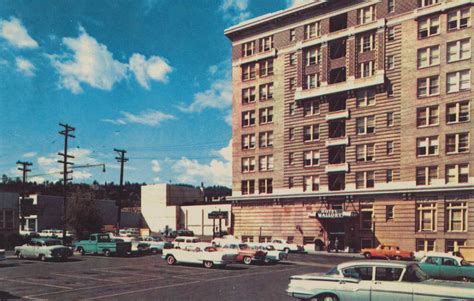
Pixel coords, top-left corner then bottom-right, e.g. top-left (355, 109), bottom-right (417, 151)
top-left (0, 254), bottom-right (349, 300)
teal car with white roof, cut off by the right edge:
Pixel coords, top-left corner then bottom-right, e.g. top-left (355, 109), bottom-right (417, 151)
top-left (420, 253), bottom-right (474, 282)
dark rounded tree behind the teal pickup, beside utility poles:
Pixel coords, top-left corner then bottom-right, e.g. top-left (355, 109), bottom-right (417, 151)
top-left (66, 192), bottom-right (102, 239)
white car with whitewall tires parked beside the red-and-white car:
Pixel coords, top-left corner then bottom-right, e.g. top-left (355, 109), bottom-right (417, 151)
top-left (162, 243), bottom-right (238, 269)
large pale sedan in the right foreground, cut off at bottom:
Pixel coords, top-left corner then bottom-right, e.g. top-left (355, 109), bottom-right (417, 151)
top-left (286, 260), bottom-right (474, 301)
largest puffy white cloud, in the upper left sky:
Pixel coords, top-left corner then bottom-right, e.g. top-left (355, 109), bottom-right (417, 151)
top-left (50, 27), bottom-right (128, 94)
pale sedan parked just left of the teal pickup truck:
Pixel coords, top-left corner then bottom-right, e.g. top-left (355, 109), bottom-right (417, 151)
top-left (15, 238), bottom-right (73, 261)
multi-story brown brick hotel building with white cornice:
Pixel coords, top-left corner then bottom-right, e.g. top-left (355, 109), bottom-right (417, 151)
top-left (225, 0), bottom-right (474, 251)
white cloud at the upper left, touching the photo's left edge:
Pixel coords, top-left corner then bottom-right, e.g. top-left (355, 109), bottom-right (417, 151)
top-left (0, 17), bottom-right (38, 48)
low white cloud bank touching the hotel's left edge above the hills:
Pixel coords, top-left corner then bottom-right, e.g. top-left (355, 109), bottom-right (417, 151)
top-left (172, 143), bottom-right (232, 186)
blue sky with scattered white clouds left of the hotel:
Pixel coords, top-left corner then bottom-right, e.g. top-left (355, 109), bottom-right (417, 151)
top-left (0, 0), bottom-right (299, 186)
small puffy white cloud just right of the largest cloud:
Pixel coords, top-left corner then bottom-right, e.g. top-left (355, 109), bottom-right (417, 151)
top-left (129, 53), bottom-right (173, 90)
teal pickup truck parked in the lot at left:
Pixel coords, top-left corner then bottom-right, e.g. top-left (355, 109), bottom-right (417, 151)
top-left (75, 233), bottom-right (132, 256)
